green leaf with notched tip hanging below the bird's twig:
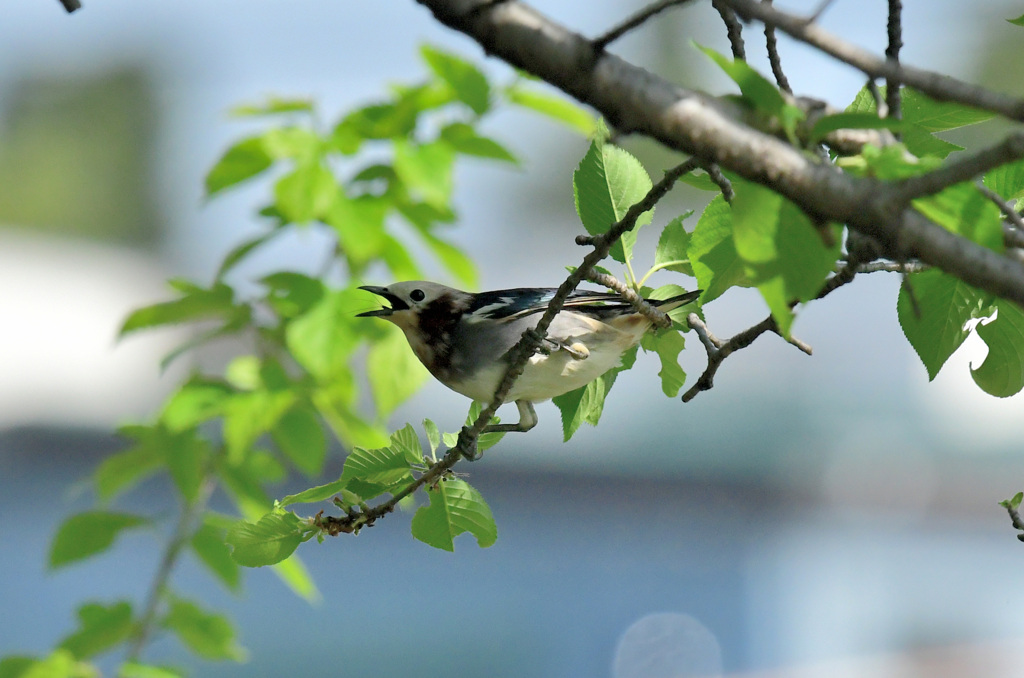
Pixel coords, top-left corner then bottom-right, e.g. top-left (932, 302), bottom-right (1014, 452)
top-left (413, 479), bottom-right (498, 551)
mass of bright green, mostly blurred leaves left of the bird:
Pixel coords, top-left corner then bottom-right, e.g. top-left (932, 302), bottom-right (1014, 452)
top-left (0, 47), bottom-right (595, 678)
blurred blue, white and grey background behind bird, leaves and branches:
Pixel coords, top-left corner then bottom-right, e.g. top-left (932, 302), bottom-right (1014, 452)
top-left (0, 0), bottom-right (1024, 678)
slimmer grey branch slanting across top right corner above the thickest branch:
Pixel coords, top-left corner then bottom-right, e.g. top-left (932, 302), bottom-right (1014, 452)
top-left (722, 0), bottom-right (1024, 122)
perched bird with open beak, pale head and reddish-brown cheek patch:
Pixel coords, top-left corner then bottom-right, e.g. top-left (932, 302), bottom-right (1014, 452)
top-left (358, 281), bottom-right (700, 431)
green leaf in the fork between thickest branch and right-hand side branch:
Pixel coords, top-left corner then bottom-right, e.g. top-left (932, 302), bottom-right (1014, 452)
top-left (913, 183), bottom-right (1005, 252)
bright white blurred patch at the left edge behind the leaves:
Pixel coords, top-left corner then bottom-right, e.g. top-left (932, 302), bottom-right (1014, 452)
top-left (0, 229), bottom-right (186, 429)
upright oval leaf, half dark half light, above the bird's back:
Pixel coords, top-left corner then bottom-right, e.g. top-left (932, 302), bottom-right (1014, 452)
top-left (572, 139), bottom-right (653, 263)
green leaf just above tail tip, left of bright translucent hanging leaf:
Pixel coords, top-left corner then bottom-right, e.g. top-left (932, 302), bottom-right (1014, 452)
top-left (686, 196), bottom-right (751, 304)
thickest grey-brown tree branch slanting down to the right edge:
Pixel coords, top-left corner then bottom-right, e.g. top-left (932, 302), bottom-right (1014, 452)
top-left (418, 0), bottom-right (1024, 305)
